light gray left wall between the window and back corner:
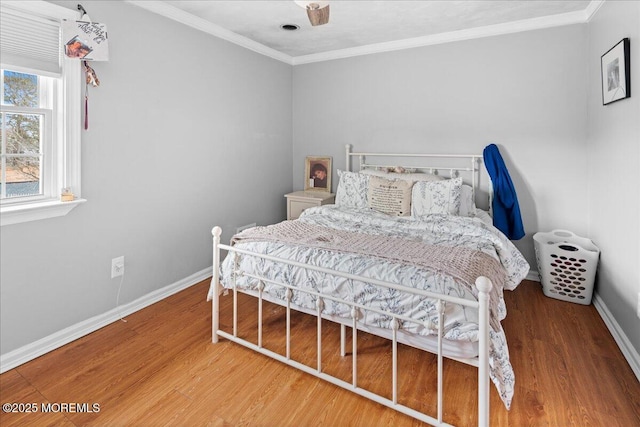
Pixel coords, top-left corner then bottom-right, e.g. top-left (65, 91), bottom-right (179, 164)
top-left (0, 1), bottom-right (293, 354)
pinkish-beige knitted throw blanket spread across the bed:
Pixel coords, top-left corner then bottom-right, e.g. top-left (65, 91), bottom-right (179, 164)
top-left (231, 221), bottom-right (505, 330)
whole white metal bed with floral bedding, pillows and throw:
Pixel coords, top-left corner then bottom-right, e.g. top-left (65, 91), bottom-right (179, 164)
top-left (209, 146), bottom-right (529, 425)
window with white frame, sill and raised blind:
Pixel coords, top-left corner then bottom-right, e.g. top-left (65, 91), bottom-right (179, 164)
top-left (0, 1), bottom-right (84, 226)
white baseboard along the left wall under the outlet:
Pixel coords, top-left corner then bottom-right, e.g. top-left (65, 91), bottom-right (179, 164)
top-left (0, 267), bottom-right (212, 374)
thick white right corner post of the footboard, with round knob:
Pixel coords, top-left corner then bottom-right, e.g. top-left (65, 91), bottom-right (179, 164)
top-left (476, 276), bottom-right (493, 427)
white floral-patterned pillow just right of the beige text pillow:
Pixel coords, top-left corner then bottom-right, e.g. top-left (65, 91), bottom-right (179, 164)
top-left (411, 178), bottom-right (462, 217)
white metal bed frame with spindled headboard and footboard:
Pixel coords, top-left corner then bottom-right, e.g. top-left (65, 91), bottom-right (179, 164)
top-left (211, 145), bottom-right (493, 426)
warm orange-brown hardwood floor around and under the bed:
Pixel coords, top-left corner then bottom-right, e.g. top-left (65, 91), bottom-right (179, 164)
top-left (0, 281), bottom-right (640, 427)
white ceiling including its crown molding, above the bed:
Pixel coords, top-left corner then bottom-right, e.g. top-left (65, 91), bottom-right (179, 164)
top-left (130, 0), bottom-right (602, 65)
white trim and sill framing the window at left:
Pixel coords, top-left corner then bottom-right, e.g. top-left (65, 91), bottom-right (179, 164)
top-left (0, 1), bottom-right (86, 226)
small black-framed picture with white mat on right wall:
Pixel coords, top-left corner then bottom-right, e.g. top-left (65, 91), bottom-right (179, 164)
top-left (600, 38), bottom-right (631, 105)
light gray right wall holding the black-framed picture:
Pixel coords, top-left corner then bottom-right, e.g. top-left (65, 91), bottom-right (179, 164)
top-left (587, 1), bottom-right (640, 351)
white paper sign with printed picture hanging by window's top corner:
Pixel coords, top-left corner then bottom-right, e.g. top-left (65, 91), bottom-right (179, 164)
top-left (62, 19), bottom-right (109, 61)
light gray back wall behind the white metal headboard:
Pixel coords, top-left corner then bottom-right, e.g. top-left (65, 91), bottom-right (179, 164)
top-left (293, 25), bottom-right (588, 268)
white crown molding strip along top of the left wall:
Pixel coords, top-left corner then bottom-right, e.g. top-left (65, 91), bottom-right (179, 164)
top-left (126, 0), bottom-right (293, 65)
